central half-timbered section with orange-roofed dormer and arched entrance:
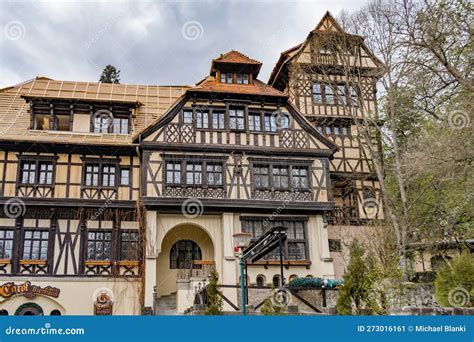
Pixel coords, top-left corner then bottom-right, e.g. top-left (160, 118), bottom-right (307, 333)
top-left (135, 51), bottom-right (337, 312)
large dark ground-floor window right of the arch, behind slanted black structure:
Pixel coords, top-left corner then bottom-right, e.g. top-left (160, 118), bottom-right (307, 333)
top-left (241, 216), bottom-right (307, 260)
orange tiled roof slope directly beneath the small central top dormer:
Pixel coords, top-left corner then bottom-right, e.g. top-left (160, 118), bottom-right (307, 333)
top-left (189, 76), bottom-right (286, 97)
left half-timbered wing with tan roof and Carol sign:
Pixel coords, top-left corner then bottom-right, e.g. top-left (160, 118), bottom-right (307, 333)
top-left (0, 77), bottom-right (188, 315)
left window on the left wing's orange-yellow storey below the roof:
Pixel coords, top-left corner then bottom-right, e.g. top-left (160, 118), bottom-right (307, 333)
top-left (20, 159), bottom-right (54, 185)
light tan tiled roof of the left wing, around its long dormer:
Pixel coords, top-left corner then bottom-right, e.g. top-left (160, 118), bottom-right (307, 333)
top-left (0, 77), bottom-right (189, 145)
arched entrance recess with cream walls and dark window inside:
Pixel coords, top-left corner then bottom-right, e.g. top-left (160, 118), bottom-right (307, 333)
top-left (156, 224), bottom-right (214, 298)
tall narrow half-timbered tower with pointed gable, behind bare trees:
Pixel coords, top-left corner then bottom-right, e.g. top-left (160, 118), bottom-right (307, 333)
top-left (268, 12), bottom-right (384, 277)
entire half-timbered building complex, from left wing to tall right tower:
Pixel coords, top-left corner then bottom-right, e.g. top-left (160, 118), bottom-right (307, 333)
top-left (0, 14), bottom-right (388, 315)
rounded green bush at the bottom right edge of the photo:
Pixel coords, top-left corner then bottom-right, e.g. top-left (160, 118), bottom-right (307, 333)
top-left (435, 252), bottom-right (474, 307)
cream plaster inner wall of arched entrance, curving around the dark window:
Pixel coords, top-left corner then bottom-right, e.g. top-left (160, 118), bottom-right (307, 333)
top-left (156, 223), bottom-right (214, 297)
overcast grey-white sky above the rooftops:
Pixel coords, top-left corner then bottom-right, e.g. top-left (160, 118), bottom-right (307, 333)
top-left (0, 0), bottom-right (363, 88)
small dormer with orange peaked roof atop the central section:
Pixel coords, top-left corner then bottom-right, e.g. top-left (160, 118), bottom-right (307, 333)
top-left (210, 50), bottom-right (262, 85)
